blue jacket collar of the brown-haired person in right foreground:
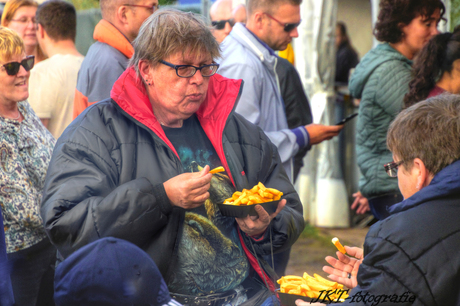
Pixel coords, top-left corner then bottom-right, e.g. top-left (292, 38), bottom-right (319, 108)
top-left (388, 160), bottom-right (460, 214)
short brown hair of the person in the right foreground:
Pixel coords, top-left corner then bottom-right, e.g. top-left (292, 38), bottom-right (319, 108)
top-left (382, 94), bottom-right (460, 174)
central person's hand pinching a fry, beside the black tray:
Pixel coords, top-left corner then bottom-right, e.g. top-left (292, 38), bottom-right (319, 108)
top-left (163, 166), bottom-right (212, 209)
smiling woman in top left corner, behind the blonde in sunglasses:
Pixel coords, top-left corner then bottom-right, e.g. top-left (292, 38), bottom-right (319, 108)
top-left (1, 0), bottom-right (46, 63)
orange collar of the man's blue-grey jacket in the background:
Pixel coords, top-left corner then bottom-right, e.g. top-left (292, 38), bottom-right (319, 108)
top-left (93, 19), bottom-right (134, 58)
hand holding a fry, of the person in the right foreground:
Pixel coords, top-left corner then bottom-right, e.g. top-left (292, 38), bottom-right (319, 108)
top-left (323, 246), bottom-right (363, 289)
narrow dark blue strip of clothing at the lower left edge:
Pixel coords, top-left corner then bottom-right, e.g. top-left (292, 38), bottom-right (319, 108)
top-left (0, 210), bottom-right (14, 306)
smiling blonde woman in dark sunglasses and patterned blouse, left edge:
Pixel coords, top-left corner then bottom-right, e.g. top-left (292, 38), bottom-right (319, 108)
top-left (0, 27), bottom-right (56, 306)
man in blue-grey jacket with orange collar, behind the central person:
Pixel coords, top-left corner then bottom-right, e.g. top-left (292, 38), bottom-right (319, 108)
top-left (73, 0), bottom-right (158, 118)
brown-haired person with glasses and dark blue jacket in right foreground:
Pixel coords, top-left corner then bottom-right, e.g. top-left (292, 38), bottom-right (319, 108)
top-left (297, 94), bottom-right (460, 306)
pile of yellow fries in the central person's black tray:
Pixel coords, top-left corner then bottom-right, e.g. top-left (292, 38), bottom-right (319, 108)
top-left (224, 182), bottom-right (283, 205)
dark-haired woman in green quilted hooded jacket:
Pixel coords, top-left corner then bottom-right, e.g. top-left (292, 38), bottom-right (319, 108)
top-left (349, 0), bottom-right (445, 220)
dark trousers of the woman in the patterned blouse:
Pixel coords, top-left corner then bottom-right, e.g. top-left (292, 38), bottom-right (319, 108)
top-left (8, 238), bottom-right (56, 306)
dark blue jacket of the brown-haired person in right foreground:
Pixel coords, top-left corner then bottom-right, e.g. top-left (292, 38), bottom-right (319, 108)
top-left (344, 161), bottom-right (460, 306)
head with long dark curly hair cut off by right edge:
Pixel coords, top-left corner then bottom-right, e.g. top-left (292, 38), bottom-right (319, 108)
top-left (404, 27), bottom-right (460, 107)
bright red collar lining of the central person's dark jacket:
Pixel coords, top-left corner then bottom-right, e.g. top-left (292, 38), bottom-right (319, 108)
top-left (110, 67), bottom-right (243, 182)
